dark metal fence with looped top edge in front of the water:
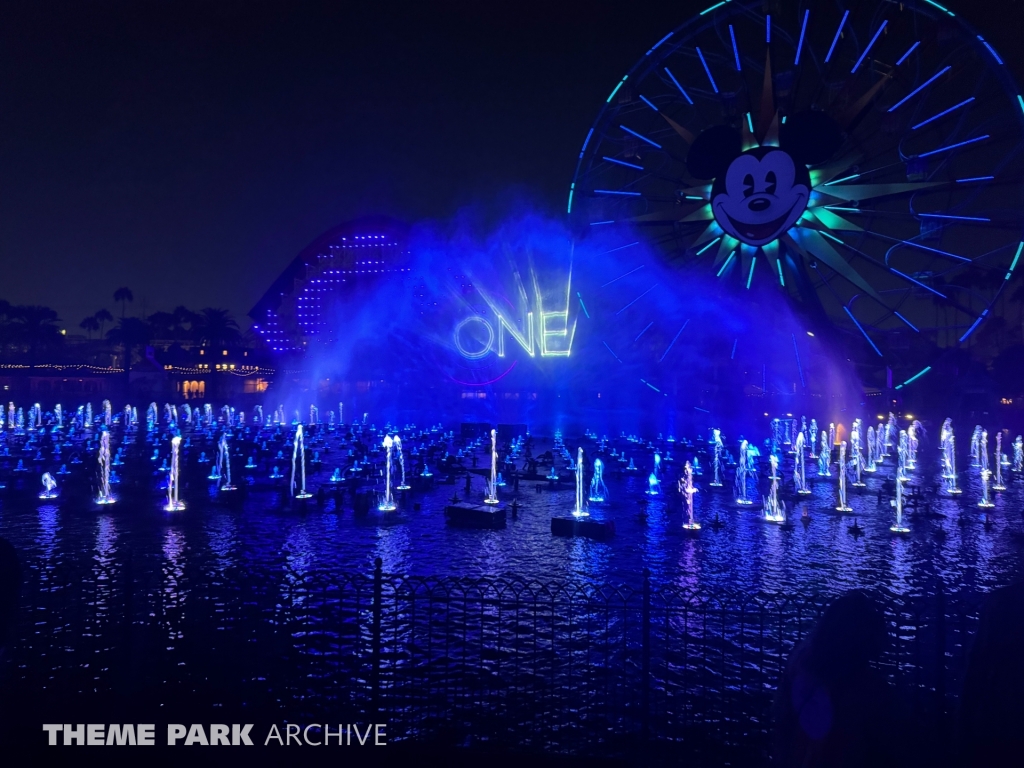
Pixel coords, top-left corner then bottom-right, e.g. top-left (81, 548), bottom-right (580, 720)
top-left (6, 553), bottom-right (979, 765)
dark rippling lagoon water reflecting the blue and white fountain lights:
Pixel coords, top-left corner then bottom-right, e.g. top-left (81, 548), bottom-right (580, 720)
top-left (0, 417), bottom-right (1024, 760)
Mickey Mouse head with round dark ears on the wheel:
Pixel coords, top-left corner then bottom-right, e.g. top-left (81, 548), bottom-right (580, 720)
top-left (686, 112), bottom-right (842, 246)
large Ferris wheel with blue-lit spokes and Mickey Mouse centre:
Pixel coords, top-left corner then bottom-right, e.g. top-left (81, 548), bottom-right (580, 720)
top-left (568, 0), bottom-right (1024, 388)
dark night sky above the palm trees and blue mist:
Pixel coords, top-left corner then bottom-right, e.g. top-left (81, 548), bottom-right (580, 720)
top-left (0, 0), bottom-right (1024, 329)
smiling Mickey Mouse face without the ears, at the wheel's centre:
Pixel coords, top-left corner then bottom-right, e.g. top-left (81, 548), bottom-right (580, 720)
top-left (711, 147), bottom-right (810, 246)
